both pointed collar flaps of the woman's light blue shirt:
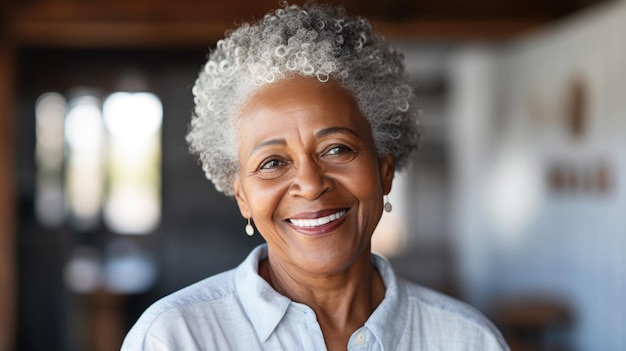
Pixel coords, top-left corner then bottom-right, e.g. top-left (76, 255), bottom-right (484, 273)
top-left (235, 244), bottom-right (407, 350)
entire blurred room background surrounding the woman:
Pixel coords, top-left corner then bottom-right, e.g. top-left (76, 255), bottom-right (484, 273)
top-left (0, 0), bottom-right (626, 351)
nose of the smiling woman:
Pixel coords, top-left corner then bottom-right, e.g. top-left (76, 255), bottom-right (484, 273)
top-left (289, 158), bottom-right (334, 200)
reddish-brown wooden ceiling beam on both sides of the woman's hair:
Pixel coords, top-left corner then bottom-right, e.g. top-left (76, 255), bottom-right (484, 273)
top-left (13, 0), bottom-right (547, 48)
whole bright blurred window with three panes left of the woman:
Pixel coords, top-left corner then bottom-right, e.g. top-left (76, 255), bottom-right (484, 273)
top-left (36, 89), bottom-right (163, 234)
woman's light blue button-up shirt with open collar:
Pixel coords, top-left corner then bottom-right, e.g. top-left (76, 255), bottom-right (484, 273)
top-left (122, 245), bottom-right (508, 351)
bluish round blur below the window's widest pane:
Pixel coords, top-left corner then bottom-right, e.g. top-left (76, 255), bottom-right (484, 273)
top-left (104, 239), bottom-right (157, 294)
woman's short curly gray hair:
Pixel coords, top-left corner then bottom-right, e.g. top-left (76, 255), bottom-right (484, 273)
top-left (187, 3), bottom-right (419, 196)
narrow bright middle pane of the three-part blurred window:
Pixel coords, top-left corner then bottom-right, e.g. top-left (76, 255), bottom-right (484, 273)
top-left (65, 95), bottom-right (105, 230)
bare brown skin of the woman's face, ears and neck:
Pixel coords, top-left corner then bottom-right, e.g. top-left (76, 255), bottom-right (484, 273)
top-left (234, 77), bottom-right (394, 350)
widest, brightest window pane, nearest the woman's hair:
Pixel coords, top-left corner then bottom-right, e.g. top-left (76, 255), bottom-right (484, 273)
top-left (103, 92), bottom-right (163, 234)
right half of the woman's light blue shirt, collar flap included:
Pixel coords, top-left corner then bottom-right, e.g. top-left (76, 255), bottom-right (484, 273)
top-left (373, 255), bottom-right (509, 351)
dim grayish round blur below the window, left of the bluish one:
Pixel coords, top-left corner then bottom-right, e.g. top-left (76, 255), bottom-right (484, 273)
top-left (65, 246), bottom-right (102, 294)
